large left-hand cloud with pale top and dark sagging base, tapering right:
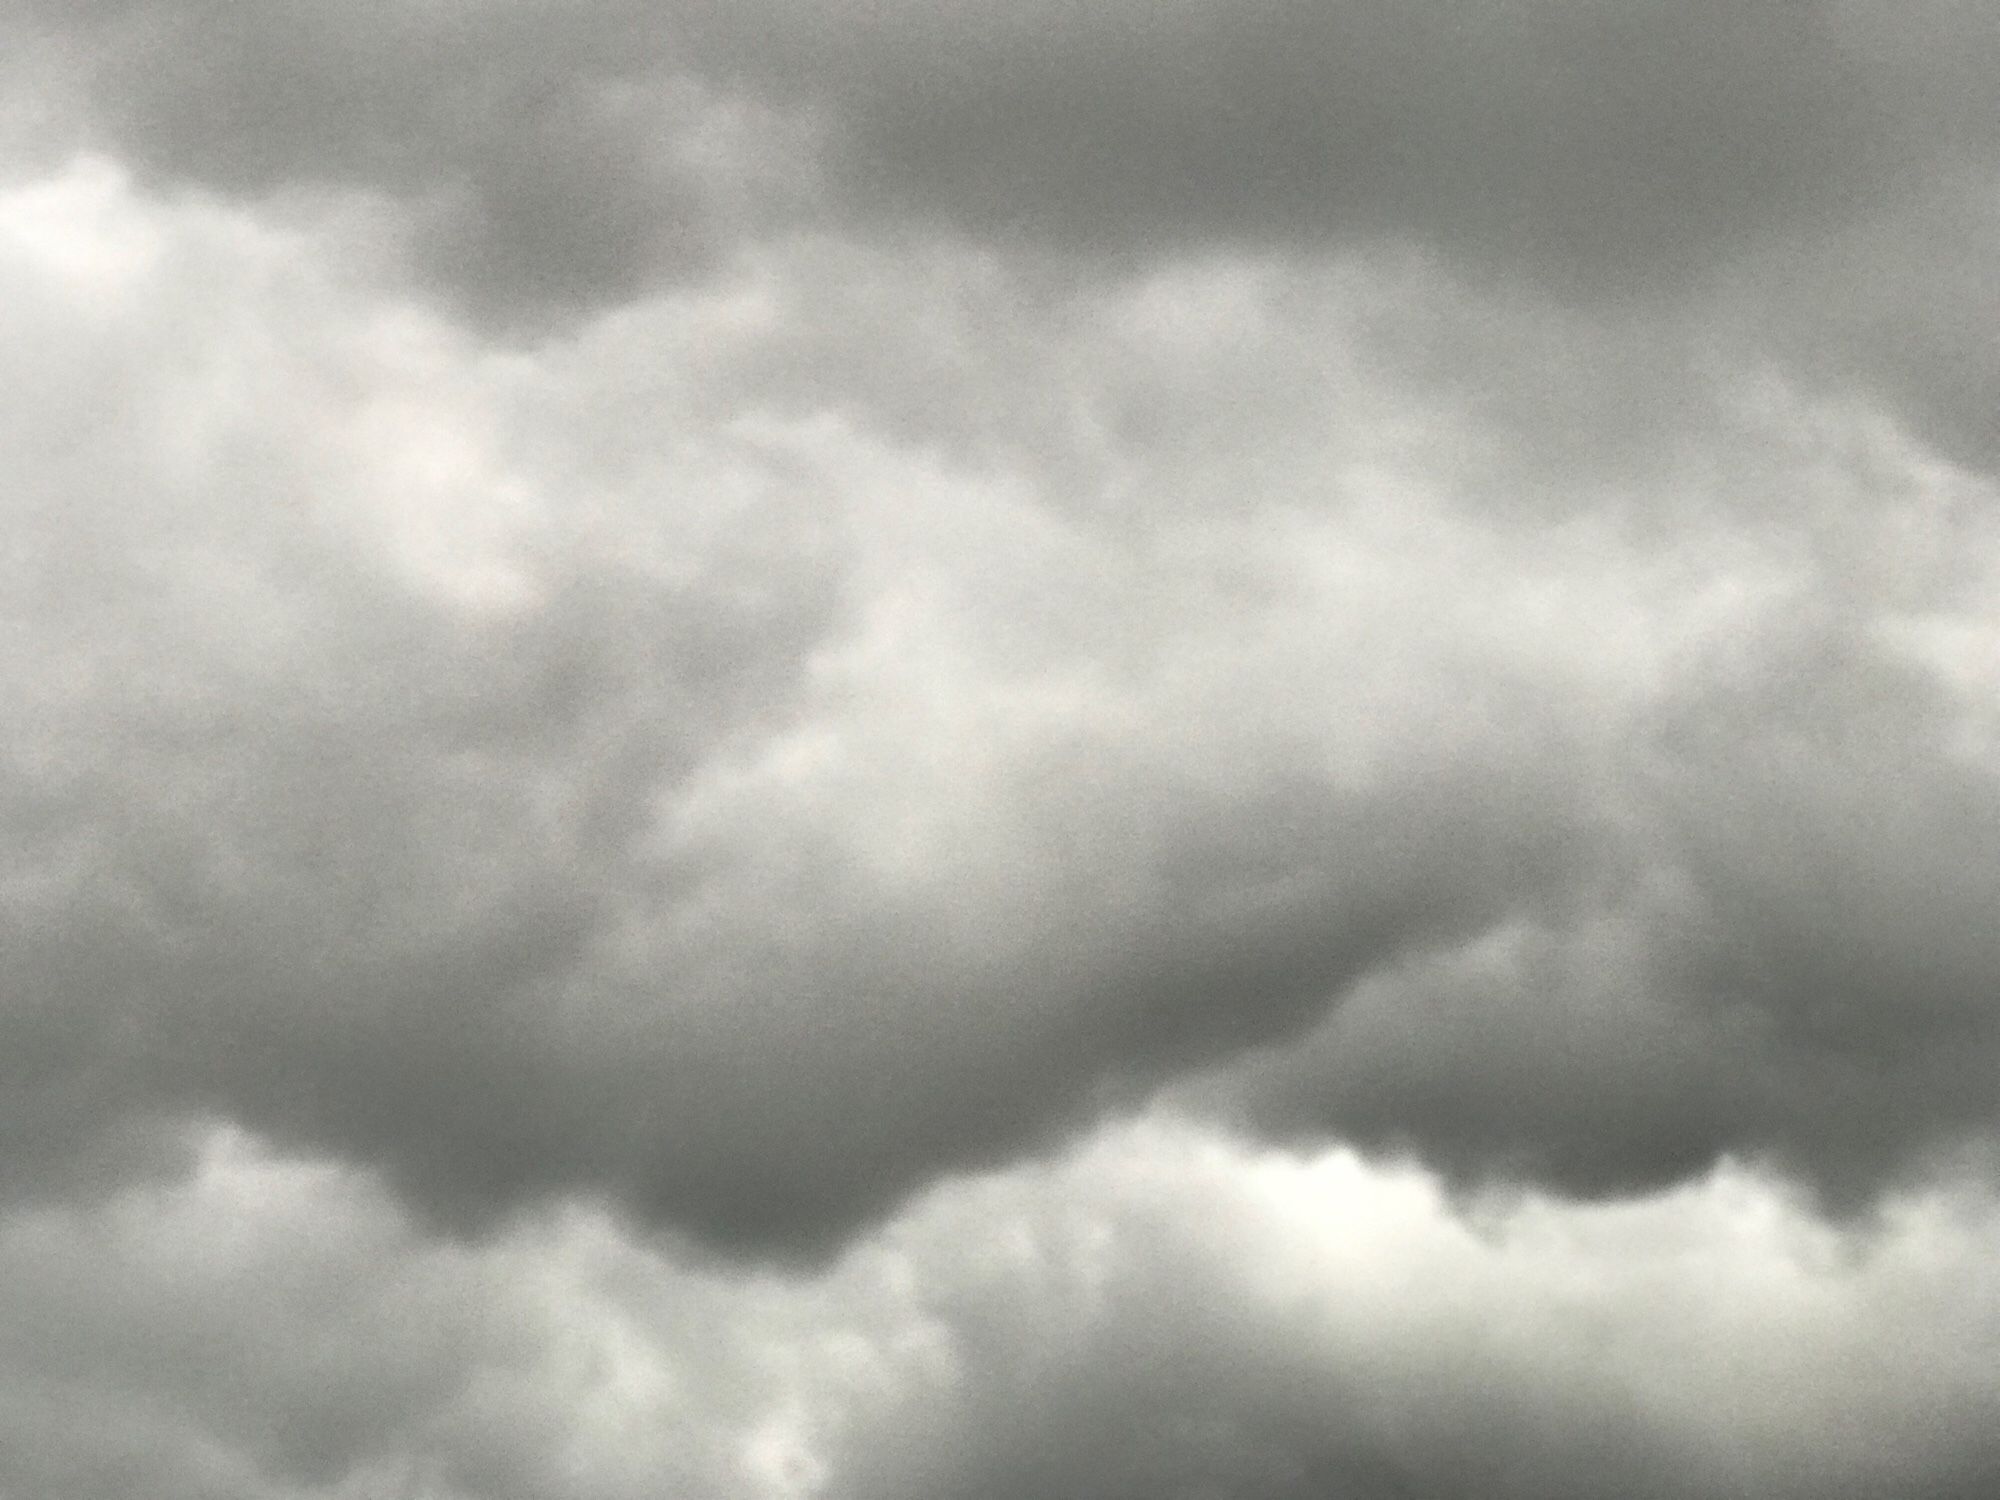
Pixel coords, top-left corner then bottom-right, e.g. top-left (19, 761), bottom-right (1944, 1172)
top-left (6, 172), bottom-right (1588, 1252)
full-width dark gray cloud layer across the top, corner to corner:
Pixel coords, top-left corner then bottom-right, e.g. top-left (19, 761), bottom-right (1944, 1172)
top-left (12, 0), bottom-right (2000, 484)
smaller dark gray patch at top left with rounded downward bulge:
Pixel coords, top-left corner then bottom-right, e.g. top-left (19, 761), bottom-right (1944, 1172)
top-left (25, 0), bottom-right (754, 330)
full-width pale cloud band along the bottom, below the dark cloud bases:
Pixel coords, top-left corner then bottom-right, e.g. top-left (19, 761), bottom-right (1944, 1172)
top-left (0, 1122), bottom-right (2000, 1500)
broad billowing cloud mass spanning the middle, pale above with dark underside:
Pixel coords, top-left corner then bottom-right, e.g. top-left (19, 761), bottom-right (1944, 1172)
top-left (6, 153), bottom-right (2000, 1252)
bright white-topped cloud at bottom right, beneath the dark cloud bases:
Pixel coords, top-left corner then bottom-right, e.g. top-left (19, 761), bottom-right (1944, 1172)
top-left (830, 1140), bottom-right (1994, 1498)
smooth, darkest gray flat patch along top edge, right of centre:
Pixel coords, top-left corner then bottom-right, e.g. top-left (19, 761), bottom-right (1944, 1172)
top-left (690, 0), bottom-right (1936, 294)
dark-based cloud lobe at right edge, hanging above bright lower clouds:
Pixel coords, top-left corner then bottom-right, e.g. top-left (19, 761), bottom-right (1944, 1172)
top-left (1194, 640), bottom-right (2000, 1212)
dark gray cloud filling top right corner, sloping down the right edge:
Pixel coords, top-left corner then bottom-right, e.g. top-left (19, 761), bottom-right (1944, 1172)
top-left (682, 0), bottom-right (2000, 476)
